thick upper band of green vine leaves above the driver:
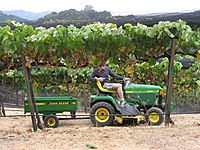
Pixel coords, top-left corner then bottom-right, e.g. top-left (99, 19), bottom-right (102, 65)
top-left (0, 20), bottom-right (200, 68)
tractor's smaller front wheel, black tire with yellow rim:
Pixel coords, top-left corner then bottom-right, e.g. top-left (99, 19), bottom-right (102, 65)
top-left (147, 107), bottom-right (164, 126)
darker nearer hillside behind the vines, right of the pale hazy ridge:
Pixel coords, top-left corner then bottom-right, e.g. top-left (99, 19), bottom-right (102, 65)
top-left (34, 9), bottom-right (200, 27)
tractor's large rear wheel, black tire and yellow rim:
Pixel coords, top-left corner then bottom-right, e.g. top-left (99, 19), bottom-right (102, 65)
top-left (90, 102), bottom-right (115, 126)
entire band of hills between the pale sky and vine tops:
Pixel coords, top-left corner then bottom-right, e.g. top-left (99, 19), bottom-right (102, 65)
top-left (0, 9), bottom-right (200, 28)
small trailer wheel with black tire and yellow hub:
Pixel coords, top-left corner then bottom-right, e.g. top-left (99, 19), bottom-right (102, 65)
top-left (44, 114), bottom-right (59, 128)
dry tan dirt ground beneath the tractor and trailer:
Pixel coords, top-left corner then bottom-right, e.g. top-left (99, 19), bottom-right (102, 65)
top-left (0, 108), bottom-right (200, 150)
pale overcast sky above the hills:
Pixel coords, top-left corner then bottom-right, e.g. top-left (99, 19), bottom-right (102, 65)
top-left (0, 0), bottom-right (200, 15)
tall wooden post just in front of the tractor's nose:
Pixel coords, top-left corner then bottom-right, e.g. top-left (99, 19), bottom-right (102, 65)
top-left (165, 39), bottom-right (176, 126)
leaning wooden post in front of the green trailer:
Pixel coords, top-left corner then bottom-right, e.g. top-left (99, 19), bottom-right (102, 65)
top-left (22, 56), bottom-right (43, 131)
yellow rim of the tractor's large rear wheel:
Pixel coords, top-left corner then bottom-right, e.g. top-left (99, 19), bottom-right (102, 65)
top-left (95, 108), bottom-right (110, 123)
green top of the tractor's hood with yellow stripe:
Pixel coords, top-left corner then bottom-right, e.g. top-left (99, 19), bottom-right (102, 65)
top-left (124, 84), bottom-right (162, 93)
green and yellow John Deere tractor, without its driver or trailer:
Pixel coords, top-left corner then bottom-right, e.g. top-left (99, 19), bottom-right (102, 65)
top-left (90, 81), bottom-right (173, 126)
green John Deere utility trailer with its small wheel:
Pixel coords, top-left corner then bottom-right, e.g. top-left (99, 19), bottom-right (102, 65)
top-left (24, 97), bottom-right (77, 128)
